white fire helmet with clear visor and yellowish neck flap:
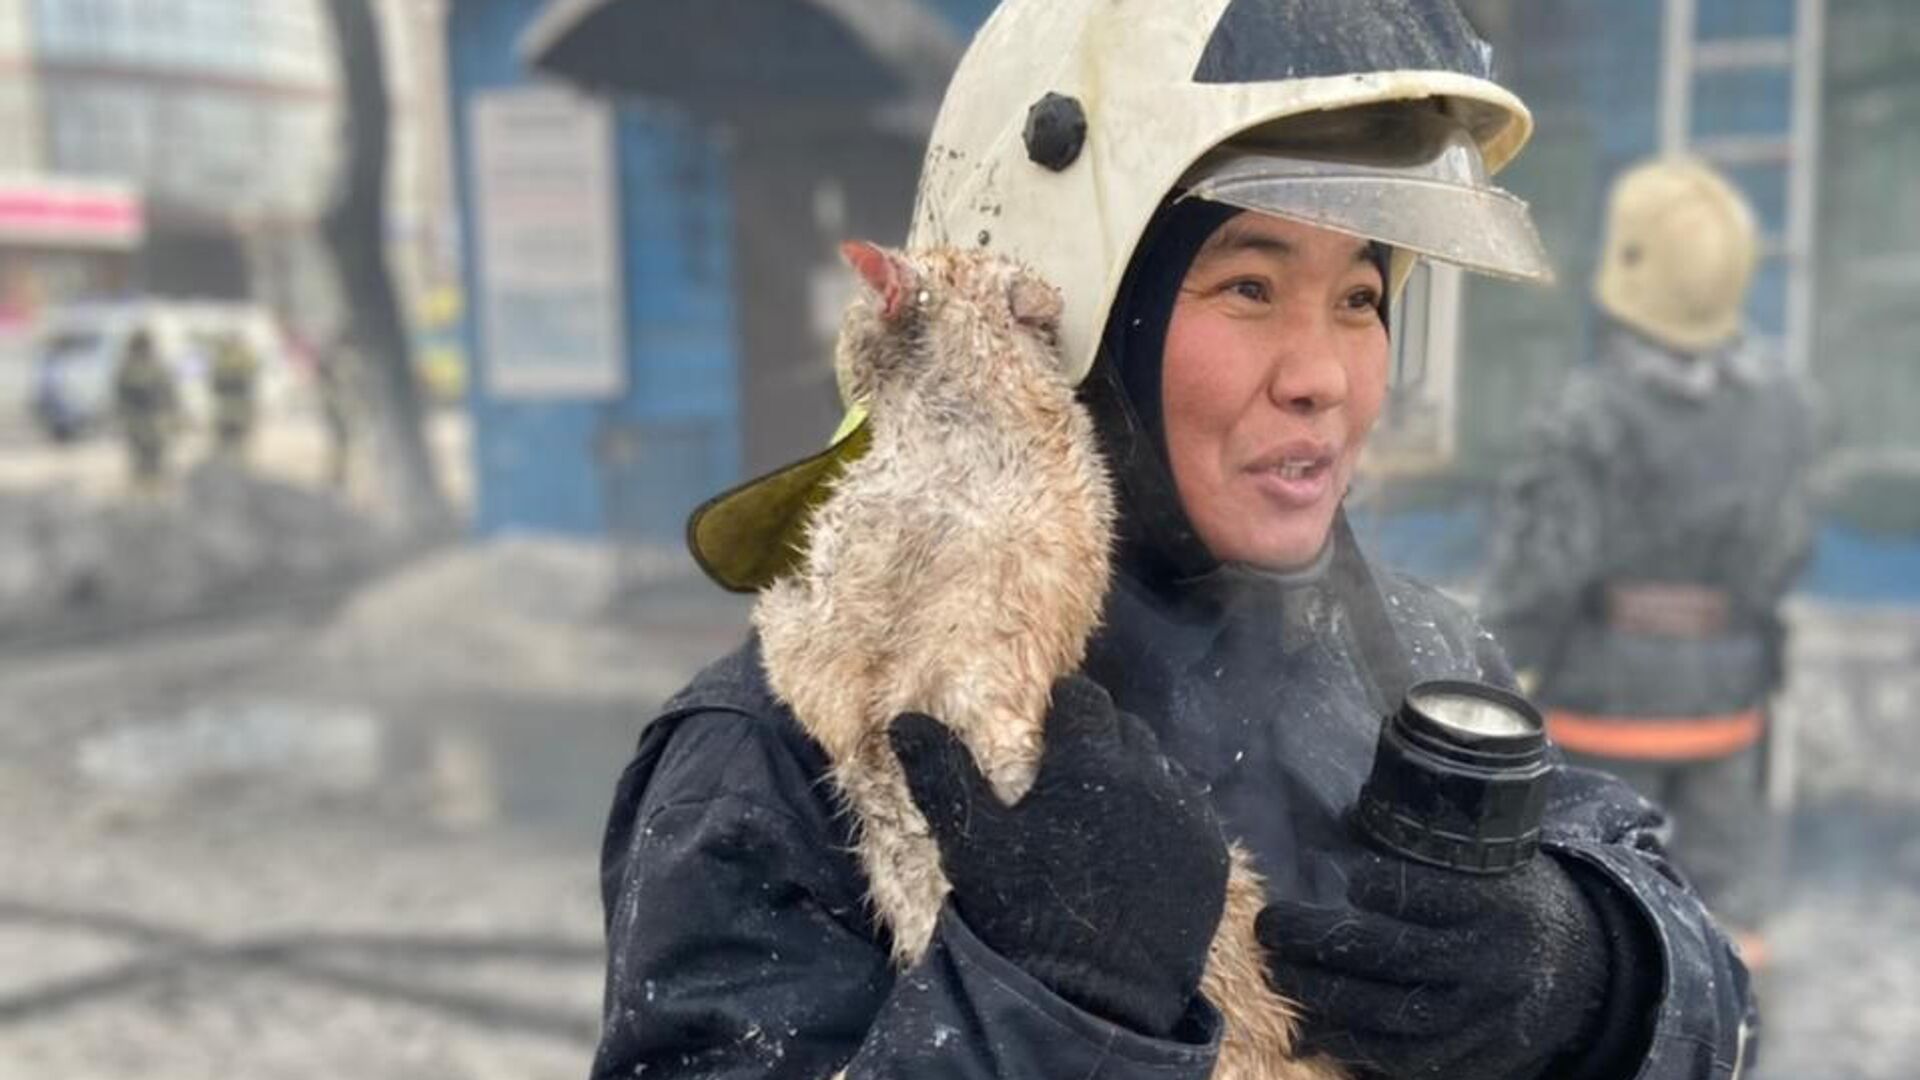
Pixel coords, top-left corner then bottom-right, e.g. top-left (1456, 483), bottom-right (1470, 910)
top-left (687, 0), bottom-right (1551, 590)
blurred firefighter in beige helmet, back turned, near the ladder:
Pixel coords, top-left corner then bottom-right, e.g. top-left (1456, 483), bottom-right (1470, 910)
top-left (1484, 158), bottom-right (1816, 967)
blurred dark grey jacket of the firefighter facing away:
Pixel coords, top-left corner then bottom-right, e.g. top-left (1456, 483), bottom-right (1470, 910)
top-left (1484, 327), bottom-right (1816, 717)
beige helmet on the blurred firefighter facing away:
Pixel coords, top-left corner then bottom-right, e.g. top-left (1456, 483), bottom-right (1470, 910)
top-left (1594, 158), bottom-right (1759, 352)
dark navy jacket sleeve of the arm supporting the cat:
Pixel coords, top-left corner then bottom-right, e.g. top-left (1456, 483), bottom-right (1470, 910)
top-left (593, 711), bottom-right (1219, 1080)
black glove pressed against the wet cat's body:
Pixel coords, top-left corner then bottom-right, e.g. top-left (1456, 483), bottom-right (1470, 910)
top-left (889, 676), bottom-right (1227, 1038)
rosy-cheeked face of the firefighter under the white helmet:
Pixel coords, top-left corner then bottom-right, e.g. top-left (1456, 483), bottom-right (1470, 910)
top-left (1162, 205), bottom-right (1386, 569)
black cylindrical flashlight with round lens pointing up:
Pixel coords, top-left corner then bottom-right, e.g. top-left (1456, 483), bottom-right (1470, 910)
top-left (1354, 678), bottom-right (1551, 874)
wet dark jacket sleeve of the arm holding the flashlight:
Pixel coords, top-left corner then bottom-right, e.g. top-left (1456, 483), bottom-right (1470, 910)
top-left (1544, 767), bottom-right (1757, 1080)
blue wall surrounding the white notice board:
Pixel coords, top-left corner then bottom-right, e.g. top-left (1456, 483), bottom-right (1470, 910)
top-left (447, 0), bottom-right (739, 542)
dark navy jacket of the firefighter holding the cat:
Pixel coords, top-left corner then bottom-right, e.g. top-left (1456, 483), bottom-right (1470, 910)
top-left (593, 545), bottom-right (1747, 1080)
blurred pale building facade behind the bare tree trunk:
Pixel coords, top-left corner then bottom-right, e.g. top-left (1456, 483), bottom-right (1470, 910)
top-left (0, 0), bottom-right (457, 336)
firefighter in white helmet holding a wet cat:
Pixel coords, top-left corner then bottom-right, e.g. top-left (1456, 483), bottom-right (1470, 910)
top-left (593, 0), bottom-right (1751, 1080)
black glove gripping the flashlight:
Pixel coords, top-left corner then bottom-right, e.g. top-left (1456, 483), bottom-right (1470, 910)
top-left (1256, 853), bottom-right (1661, 1080)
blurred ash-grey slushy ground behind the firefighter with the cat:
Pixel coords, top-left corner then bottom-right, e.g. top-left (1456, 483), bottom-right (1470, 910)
top-left (0, 526), bottom-right (1920, 1080)
